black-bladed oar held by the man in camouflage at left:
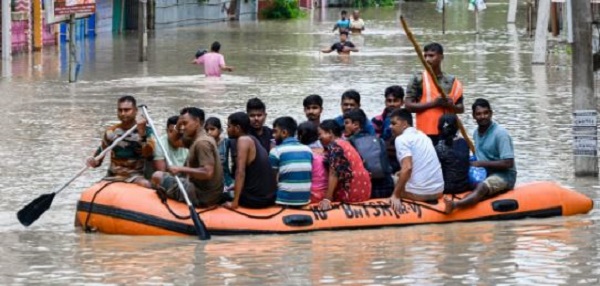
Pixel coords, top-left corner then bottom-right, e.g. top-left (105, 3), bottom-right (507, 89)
top-left (17, 125), bottom-right (137, 226)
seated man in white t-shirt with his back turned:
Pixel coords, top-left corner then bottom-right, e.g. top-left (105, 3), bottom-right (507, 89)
top-left (390, 108), bottom-right (444, 210)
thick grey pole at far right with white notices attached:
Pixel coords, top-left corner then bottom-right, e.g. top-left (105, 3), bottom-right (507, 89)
top-left (568, 0), bottom-right (598, 177)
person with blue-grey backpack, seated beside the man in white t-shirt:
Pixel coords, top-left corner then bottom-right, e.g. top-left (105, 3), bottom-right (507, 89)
top-left (344, 108), bottom-right (394, 199)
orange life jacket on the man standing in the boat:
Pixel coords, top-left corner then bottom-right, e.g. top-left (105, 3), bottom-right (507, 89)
top-left (416, 71), bottom-right (463, 135)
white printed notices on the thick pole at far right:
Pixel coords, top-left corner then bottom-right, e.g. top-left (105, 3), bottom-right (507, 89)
top-left (573, 110), bottom-right (598, 157)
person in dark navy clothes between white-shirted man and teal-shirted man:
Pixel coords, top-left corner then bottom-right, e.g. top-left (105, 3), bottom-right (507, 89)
top-left (435, 113), bottom-right (469, 194)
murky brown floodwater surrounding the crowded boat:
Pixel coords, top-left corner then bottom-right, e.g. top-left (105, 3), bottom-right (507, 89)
top-left (0, 1), bottom-right (600, 285)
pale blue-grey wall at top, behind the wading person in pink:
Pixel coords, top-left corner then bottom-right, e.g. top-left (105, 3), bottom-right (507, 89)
top-left (155, 0), bottom-right (257, 29)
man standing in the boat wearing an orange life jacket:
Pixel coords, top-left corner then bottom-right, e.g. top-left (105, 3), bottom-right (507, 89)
top-left (405, 43), bottom-right (465, 146)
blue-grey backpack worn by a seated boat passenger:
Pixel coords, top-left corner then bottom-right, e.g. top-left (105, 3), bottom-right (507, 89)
top-left (349, 135), bottom-right (392, 179)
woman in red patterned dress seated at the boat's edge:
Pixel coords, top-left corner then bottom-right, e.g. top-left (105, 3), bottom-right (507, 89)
top-left (319, 119), bottom-right (371, 210)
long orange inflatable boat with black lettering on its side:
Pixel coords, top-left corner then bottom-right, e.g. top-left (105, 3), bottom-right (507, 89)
top-left (77, 182), bottom-right (593, 235)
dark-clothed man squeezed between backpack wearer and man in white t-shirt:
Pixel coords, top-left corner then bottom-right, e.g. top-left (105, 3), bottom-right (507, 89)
top-left (371, 85), bottom-right (404, 173)
